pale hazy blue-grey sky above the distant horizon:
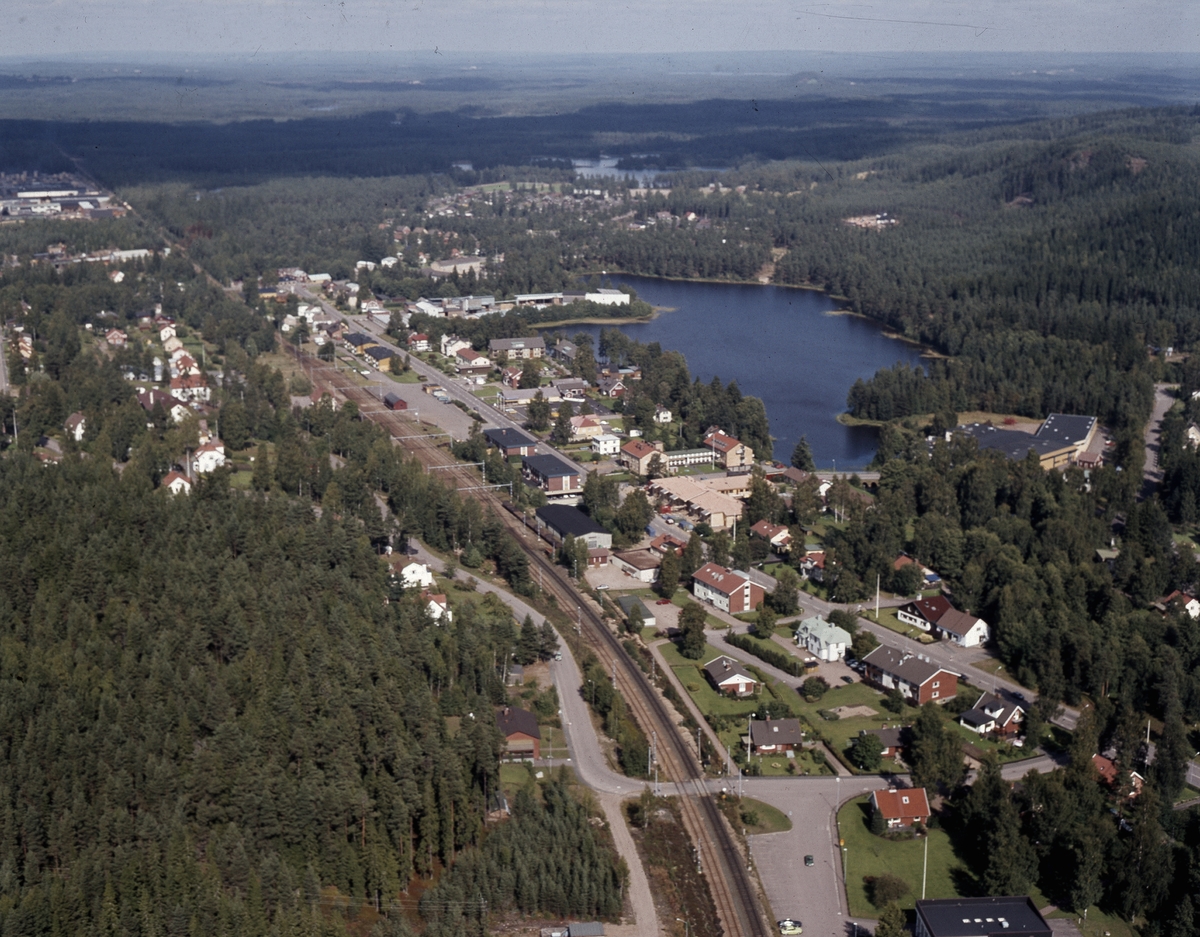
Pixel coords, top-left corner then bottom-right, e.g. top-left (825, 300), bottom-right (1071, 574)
top-left (7, 0), bottom-right (1200, 60)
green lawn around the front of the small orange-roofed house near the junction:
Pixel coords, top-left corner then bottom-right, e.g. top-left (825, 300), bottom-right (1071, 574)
top-left (838, 797), bottom-right (969, 918)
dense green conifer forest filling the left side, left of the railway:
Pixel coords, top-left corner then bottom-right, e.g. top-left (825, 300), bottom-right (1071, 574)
top-left (0, 224), bottom-right (623, 935)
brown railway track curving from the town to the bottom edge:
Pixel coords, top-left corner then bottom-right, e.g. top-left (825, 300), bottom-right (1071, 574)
top-left (287, 346), bottom-right (770, 937)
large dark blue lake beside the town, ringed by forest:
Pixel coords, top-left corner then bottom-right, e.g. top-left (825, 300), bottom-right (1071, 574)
top-left (563, 276), bottom-right (920, 469)
